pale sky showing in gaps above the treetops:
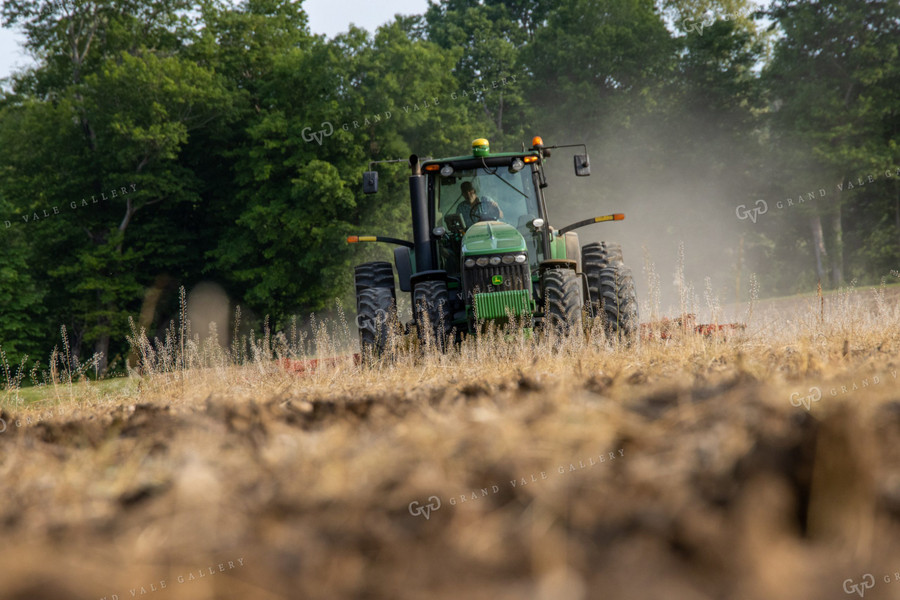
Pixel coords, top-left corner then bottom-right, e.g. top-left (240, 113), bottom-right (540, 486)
top-left (0, 0), bottom-right (428, 78)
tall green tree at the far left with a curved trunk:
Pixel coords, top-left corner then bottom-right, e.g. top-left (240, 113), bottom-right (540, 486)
top-left (3, 0), bottom-right (236, 367)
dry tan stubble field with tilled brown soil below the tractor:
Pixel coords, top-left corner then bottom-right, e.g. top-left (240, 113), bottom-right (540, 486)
top-left (0, 282), bottom-right (900, 600)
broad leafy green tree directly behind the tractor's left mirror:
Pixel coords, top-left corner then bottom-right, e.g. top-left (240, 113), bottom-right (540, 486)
top-left (212, 14), bottom-right (476, 322)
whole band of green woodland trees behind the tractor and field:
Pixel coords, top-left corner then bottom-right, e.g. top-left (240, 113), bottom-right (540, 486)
top-left (0, 0), bottom-right (900, 360)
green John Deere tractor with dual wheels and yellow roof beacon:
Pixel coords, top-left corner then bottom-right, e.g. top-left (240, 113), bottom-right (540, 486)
top-left (347, 137), bottom-right (638, 353)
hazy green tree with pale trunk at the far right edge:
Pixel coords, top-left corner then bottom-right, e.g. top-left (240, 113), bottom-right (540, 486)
top-left (765, 0), bottom-right (900, 286)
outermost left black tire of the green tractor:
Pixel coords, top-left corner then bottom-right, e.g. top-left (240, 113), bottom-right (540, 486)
top-left (355, 261), bottom-right (397, 356)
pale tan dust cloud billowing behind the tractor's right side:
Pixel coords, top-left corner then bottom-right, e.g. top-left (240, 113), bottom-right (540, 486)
top-left (532, 119), bottom-right (805, 320)
